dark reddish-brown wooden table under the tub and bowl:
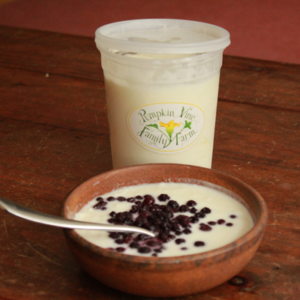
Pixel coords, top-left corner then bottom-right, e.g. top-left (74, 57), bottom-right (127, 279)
top-left (0, 26), bottom-right (300, 300)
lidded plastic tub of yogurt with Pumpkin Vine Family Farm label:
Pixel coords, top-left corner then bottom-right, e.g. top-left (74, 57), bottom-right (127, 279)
top-left (95, 19), bottom-right (230, 168)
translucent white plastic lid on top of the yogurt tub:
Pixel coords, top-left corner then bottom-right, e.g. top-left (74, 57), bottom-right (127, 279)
top-left (95, 19), bottom-right (230, 54)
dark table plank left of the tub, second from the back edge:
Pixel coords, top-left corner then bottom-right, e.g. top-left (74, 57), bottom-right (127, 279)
top-left (0, 67), bottom-right (109, 135)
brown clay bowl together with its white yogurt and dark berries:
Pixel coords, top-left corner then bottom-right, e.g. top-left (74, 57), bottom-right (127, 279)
top-left (62, 164), bottom-right (267, 297)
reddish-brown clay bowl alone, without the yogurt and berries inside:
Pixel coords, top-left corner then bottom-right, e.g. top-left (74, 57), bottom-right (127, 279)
top-left (63, 164), bottom-right (267, 297)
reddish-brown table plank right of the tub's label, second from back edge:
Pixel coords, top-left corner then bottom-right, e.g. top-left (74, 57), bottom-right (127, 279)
top-left (214, 102), bottom-right (300, 171)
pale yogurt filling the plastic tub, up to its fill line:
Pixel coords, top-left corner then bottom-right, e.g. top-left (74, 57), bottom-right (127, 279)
top-left (104, 71), bottom-right (219, 168)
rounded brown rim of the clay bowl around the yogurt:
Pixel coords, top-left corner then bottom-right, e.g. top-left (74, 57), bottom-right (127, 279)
top-left (61, 163), bottom-right (268, 265)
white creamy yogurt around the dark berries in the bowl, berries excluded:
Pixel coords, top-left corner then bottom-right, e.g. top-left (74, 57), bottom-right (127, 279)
top-left (74, 183), bottom-right (254, 257)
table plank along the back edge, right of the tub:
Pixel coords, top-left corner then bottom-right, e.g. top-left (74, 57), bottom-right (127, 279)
top-left (219, 56), bottom-right (300, 111)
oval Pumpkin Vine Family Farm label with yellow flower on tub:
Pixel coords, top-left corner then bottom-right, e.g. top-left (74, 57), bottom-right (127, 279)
top-left (127, 102), bottom-right (205, 153)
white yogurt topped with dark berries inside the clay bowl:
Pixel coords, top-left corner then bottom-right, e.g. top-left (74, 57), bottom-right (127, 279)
top-left (74, 182), bottom-right (254, 257)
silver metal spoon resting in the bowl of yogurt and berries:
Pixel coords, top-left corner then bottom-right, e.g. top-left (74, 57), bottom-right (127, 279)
top-left (0, 198), bottom-right (155, 237)
